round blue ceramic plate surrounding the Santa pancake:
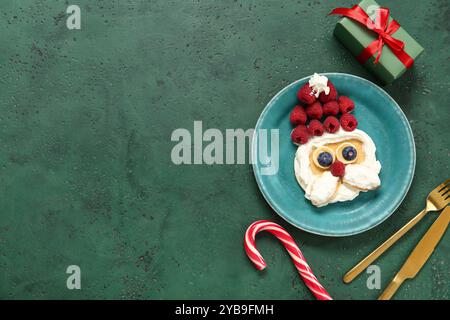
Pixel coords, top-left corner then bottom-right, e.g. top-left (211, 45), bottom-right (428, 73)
top-left (252, 73), bottom-right (416, 236)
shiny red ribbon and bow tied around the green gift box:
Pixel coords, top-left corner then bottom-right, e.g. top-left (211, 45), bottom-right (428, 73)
top-left (330, 5), bottom-right (414, 68)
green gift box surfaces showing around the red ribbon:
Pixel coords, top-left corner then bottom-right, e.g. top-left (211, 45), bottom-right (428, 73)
top-left (334, 0), bottom-right (424, 84)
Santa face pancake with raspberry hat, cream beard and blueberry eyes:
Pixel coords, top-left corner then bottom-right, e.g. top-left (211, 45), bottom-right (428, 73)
top-left (290, 74), bottom-right (381, 207)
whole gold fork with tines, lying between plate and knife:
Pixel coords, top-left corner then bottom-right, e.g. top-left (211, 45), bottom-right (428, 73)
top-left (344, 179), bottom-right (450, 283)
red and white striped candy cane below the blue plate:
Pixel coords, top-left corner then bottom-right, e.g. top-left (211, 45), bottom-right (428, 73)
top-left (244, 220), bottom-right (332, 300)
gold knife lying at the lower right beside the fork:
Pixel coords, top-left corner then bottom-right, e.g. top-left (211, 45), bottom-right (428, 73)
top-left (378, 206), bottom-right (450, 300)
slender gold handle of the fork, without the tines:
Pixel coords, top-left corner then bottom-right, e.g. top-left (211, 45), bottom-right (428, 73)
top-left (344, 208), bottom-right (429, 283)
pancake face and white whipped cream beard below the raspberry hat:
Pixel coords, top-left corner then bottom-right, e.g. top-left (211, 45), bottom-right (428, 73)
top-left (294, 129), bottom-right (381, 207)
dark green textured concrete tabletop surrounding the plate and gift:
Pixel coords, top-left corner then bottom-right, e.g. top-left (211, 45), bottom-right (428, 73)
top-left (0, 0), bottom-right (450, 299)
